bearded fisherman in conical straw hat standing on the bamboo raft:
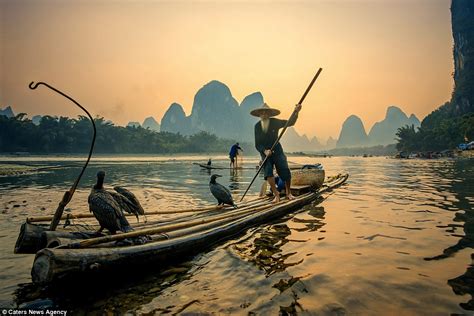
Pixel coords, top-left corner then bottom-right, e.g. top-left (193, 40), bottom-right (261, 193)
top-left (250, 103), bottom-right (301, 203)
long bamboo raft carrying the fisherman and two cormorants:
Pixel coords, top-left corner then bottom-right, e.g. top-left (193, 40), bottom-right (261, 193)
top-left (15, 170), bottom-right (348, 284)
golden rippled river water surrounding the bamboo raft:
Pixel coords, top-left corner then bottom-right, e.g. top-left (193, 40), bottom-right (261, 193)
top-left (0, 156), bottom-right (474, 315)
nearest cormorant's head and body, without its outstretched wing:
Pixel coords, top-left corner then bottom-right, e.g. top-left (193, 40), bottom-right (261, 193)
top-left (88, 171), bottom-right (133, 234)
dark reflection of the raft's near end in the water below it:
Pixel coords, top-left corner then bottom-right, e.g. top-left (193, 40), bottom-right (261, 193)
top-left (14, 262), bottom-right (193, 313)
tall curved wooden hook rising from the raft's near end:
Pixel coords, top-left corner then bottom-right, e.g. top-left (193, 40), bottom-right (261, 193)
top-left (28, 81), bottom-right (97, 230)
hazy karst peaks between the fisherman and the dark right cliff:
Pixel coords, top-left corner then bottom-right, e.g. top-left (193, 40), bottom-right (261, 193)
top-left (336, 106), bottom-right (420, 148)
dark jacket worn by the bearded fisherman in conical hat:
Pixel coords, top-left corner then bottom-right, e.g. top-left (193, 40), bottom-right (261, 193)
top-left (255, 113), bottom-right (298, 155)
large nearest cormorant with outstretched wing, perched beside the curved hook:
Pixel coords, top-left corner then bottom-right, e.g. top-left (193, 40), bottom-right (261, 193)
top-left (88, 171), bottom-right (144, 234)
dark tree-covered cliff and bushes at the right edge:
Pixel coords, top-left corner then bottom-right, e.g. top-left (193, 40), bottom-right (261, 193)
top-left (397, 0), bottom-right (474, 151)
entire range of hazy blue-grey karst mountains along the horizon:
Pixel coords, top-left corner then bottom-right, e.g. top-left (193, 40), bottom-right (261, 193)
top-left (0, 87), bottom-right (420, 151)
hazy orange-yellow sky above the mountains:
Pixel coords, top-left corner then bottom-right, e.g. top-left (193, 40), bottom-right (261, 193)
top-left (0, 0), bottom-right (453, 139)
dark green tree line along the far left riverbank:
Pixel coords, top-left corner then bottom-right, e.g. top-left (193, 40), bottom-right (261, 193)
top-left (0, 113), bottom-right (253, 154)
